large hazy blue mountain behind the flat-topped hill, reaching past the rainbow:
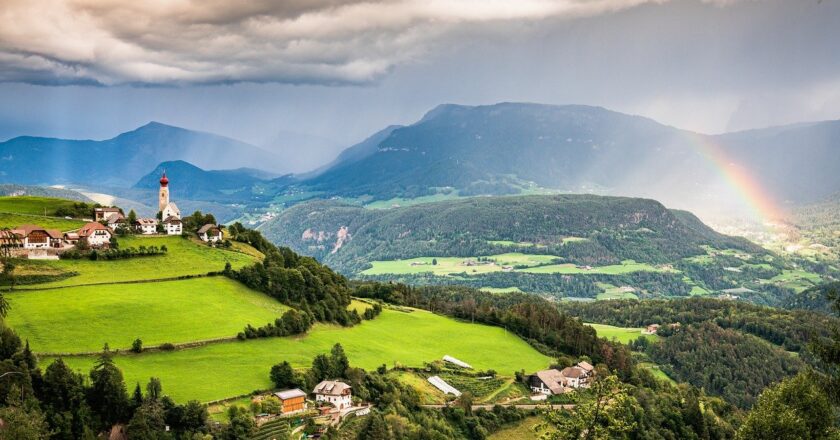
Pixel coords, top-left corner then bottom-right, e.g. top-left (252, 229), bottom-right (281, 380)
top-left (299, 103), bottom-right (840, 220)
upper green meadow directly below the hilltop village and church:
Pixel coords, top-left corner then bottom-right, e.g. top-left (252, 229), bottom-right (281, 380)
top-left (15, 236), bottom-right (257, 288)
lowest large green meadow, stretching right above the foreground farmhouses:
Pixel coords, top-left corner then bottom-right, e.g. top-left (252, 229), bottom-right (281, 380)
top-left (52, 309), bottom-right (551, 402)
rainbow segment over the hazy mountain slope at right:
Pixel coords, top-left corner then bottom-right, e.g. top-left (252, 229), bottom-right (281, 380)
top-left (687, 133), bottom-right (787, 223)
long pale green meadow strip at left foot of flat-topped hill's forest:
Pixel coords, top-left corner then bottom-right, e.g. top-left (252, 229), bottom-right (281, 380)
top-left (362, 252), bottom-right (557, 276)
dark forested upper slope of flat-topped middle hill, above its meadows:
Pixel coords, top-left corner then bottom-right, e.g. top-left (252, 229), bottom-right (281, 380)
top-left (261, 195), bottom-right (763, 274)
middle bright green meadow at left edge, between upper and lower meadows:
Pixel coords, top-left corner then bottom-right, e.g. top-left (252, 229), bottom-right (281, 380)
top-left (5, 277), bottom-right (288, 353)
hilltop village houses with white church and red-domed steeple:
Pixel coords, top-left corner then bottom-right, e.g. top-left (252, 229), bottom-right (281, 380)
top-left (0, 172), bottom-right (224, 259)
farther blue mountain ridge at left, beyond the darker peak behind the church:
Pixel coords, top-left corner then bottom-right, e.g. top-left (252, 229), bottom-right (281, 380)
top-left (0, 122), bottom-right (281, 186)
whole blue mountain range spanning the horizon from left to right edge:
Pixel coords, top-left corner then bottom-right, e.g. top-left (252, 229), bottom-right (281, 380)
top-left (0, 103), bottom-right (840, 223)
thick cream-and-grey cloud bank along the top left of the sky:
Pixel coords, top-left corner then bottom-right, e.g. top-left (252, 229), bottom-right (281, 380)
top-left (0, 0), bottom-right (676, 85)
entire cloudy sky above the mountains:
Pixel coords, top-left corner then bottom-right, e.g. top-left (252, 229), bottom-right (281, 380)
top-left (0, 0), bottom-right (840, 172)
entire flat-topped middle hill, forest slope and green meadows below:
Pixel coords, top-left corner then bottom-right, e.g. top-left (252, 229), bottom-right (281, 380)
top-left (261, 195), bottom-right (820, 304)
